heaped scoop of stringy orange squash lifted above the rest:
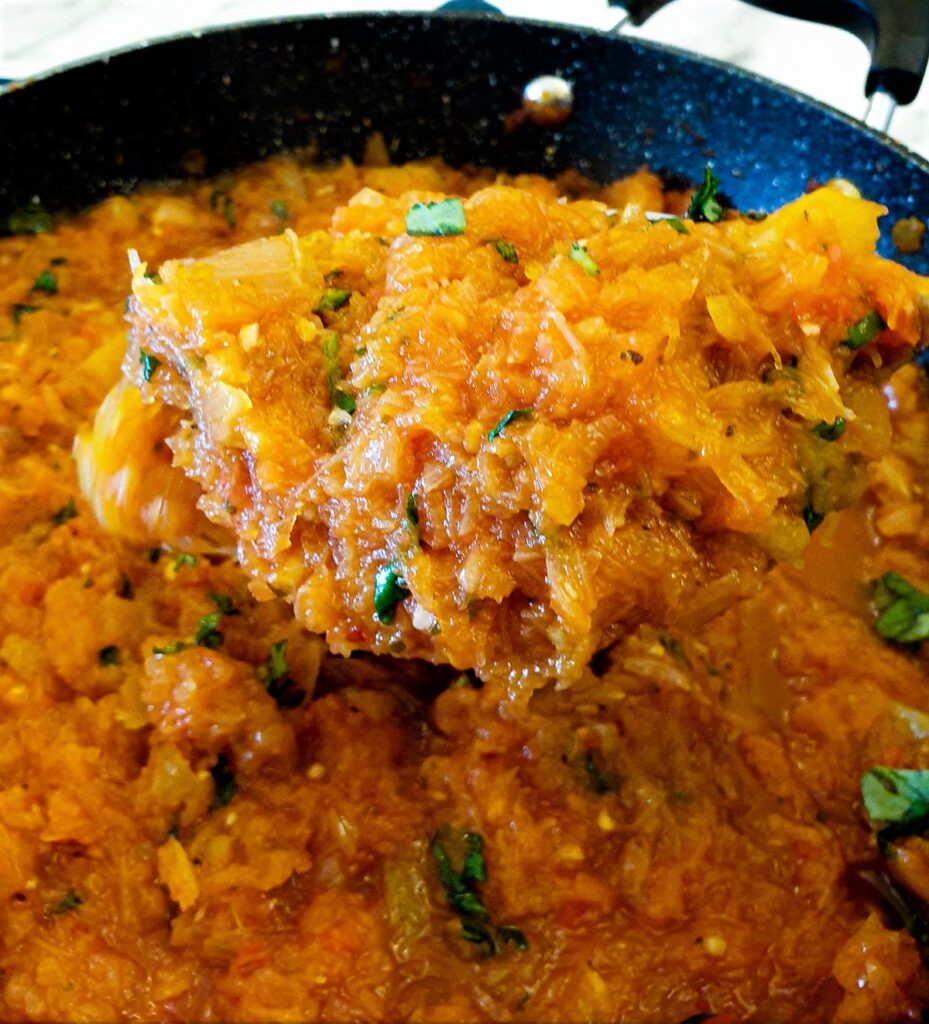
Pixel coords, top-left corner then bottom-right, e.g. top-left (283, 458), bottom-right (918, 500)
top-left (124, 185), bottom-right (929, 692)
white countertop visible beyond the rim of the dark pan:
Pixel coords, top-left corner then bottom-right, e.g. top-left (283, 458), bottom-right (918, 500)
top-left (0, 0), bottom-right (929, 159)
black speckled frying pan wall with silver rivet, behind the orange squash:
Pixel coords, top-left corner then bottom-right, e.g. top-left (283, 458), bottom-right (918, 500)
top-left (0, 0), bottom-right (929, 273)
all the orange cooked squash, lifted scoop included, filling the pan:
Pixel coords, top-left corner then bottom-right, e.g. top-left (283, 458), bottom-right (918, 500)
top-left (0, 158), bottom-right (929, 1024)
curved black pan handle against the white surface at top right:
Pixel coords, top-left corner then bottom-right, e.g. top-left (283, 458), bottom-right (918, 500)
top-left (609, 0), bottom-right (929, 104)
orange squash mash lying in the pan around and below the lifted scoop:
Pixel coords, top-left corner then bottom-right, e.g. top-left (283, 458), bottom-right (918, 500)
top-left (0, 153), bottom-right (929, 1022)
